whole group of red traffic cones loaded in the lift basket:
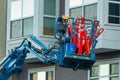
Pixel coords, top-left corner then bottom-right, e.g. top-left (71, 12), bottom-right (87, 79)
top-left (66, 17), bottom-right (104, 55)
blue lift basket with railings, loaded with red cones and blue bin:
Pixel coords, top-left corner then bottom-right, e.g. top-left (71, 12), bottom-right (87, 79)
top-left (55, 17), bottom-right (103, 70)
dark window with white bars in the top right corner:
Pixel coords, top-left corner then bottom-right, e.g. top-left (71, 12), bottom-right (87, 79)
top-left (108, 0), bottom-right (120, 24)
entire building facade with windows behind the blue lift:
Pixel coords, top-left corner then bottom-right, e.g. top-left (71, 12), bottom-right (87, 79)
top-left (0, 0), bottom-right (120, 80)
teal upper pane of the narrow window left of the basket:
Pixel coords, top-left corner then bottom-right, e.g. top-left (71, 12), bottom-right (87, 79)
top-left (44, 0), bottom-right (56, 16)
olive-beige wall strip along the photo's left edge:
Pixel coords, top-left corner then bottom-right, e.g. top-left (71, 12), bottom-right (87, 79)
top-left (0, 0), bottom-right (7, 60)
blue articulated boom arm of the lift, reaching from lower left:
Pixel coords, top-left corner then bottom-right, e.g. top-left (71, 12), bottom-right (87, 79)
top-left (0, 36), bottom-right (58, 80)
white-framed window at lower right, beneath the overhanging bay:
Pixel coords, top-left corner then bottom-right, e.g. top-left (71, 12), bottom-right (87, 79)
top-left (90, 63), bottom-right (119, 80)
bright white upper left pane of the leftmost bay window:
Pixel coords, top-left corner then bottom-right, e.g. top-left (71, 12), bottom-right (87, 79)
top-left (11, 0), bottom-right (22, 20)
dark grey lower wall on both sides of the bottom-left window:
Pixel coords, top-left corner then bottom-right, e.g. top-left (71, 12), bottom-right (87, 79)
top-left (12, 62), bottom-right (88, 80)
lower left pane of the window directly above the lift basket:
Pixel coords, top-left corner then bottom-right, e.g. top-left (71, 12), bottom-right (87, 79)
top-left (70, 7), bottom-right (82, 18)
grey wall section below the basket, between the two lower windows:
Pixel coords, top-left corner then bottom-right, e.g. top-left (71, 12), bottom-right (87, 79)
top-left (55, 66), bottom-right (88, 80)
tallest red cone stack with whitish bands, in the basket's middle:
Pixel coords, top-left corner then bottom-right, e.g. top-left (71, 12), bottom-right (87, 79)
top-left (76, 17), bottom-right (90, 55)
